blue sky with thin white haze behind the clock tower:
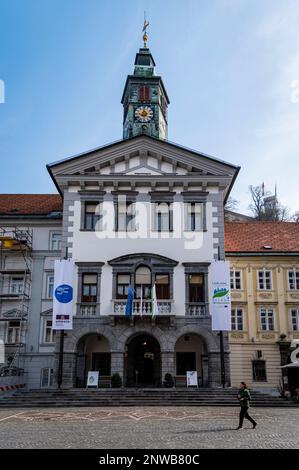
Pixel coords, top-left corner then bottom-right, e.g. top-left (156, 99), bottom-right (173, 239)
top-left (0, 0), bottom-right (299, 213)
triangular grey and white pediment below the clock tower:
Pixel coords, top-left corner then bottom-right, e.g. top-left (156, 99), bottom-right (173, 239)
top-left (48, 135), bottom-right (238, 191)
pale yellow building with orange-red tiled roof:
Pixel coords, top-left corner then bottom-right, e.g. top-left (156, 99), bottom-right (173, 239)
top-left (225, 221), bottom-right (299, 393)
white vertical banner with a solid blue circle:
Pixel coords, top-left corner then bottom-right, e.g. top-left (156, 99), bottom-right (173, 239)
top-left (52, 260), bottom-right (74, 330)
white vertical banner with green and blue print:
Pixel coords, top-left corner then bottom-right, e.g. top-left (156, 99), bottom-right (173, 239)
top-left (210, 261), bottom-right (231, 331)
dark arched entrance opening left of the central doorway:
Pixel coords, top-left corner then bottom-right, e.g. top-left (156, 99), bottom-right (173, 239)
top-left (75, 333), bottom-right (111, 388)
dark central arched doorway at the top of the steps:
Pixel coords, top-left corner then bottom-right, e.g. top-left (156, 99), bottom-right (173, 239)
top-left (125, 333), bottom-right (161, 387)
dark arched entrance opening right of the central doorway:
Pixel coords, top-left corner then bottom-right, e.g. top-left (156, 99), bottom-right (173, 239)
top-left (175, 333), bottom-right (208, 386)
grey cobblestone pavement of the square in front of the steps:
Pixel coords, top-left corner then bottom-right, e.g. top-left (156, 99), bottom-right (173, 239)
top-left (0, 407), bottom-right (299, 449)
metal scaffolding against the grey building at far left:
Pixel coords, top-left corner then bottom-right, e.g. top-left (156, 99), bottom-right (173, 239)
top-left (0, 227), bottom-right (32, 375)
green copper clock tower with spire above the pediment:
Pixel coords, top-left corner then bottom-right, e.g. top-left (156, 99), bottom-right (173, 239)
top-left (121, 33), bottom-right (169, 140)
